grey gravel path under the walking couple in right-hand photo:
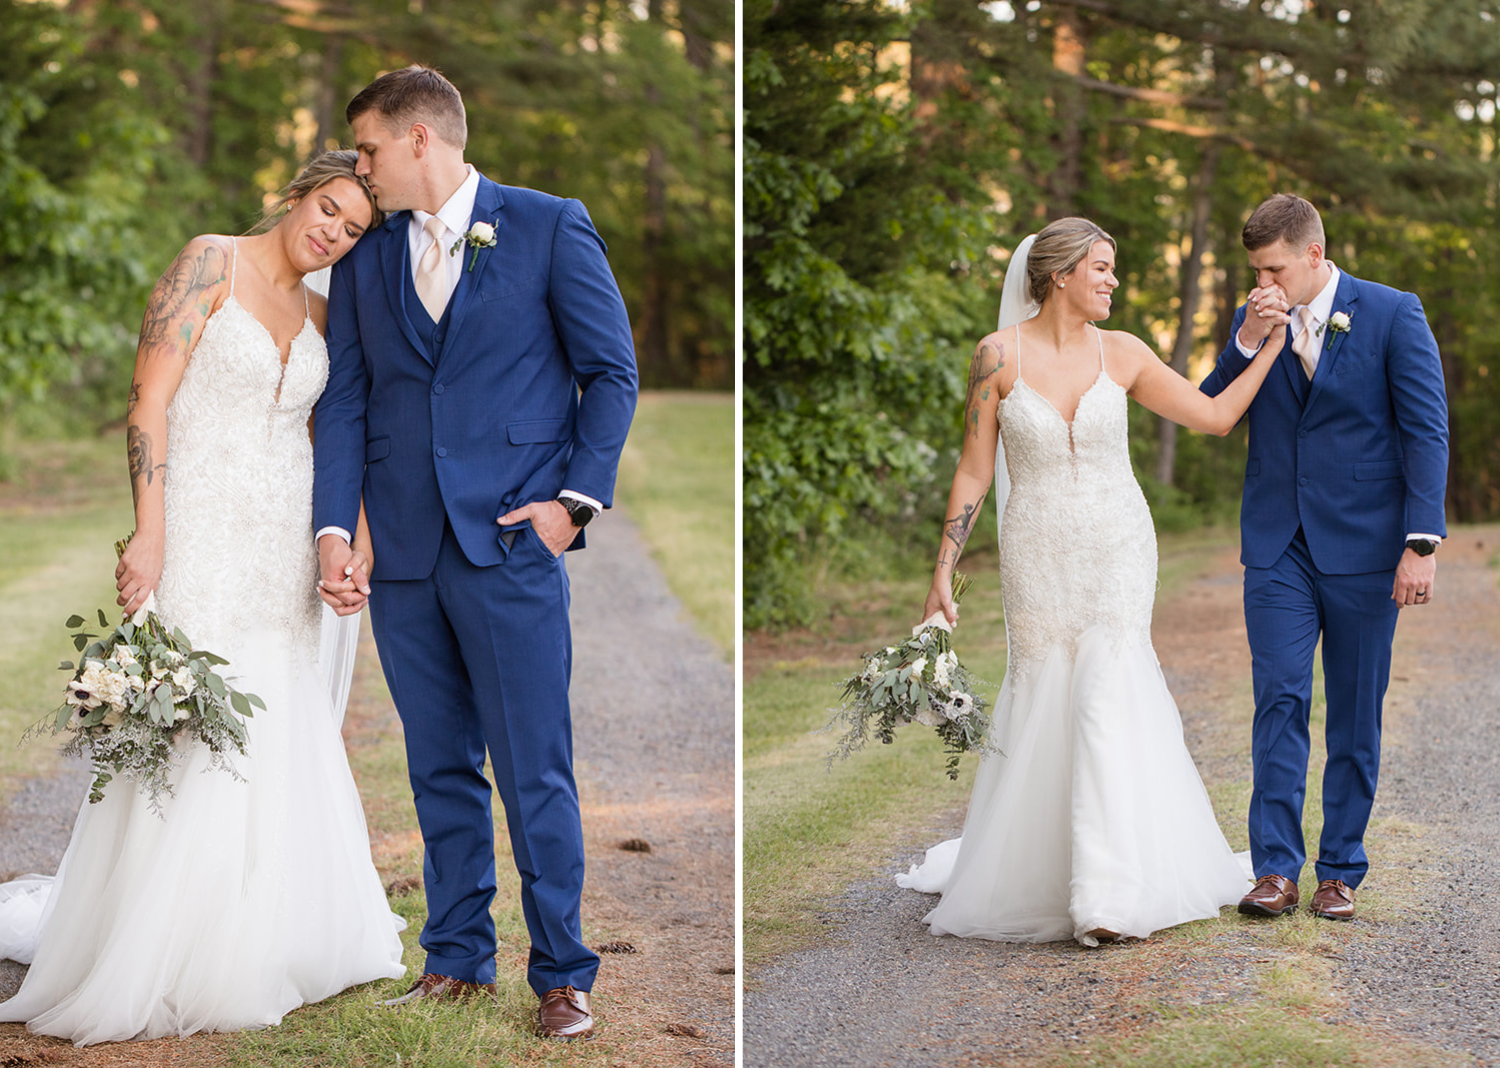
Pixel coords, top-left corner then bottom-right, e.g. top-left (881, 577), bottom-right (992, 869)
top-left (744, 528), bottom-right (1500, 1068)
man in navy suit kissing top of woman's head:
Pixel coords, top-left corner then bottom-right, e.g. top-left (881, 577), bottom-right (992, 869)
top-left (314, 66), bottom-right (636, 1038)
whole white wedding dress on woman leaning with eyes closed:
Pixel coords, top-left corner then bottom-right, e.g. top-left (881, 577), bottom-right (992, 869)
top-left (0, 240), bottom-right (405, 1046)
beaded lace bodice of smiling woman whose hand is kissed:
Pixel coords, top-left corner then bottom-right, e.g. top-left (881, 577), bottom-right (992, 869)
top-left (999, 329), bottom-right (1157, 674)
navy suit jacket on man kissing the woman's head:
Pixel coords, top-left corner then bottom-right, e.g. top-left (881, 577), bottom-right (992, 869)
top-left (314, 176), bottom-right (638, 579)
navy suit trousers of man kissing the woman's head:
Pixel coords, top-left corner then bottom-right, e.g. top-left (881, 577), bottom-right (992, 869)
top-left (369, 527), bottom-right (599, 995)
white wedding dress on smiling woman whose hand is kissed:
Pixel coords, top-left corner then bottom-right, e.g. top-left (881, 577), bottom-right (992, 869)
top-left (897, 327), bottom-right (1250, 945)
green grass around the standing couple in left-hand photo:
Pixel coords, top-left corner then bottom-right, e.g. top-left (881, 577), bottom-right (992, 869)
top-left (0, 393), bottom-right (735, 1068)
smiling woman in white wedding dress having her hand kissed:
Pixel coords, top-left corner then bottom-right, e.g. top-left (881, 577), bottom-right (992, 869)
top-left (897, 219), bottom-right (1289, 945)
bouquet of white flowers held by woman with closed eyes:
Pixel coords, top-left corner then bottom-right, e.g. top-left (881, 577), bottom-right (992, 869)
top-left (26, 539), bottom-right (266, 816)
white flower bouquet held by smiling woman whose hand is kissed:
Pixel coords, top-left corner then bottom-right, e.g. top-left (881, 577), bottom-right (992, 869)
top-left (828, 575), bottom-right (990, 779)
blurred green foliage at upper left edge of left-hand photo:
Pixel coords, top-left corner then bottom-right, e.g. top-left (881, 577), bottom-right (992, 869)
top-left (0, 0), bottom-right (165, 416)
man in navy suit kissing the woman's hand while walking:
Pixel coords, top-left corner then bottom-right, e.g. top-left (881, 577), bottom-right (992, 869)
top-left (1202, 194), bottom-right (1448, 920)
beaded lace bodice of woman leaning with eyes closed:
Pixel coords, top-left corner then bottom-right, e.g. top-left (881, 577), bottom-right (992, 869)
top-left (156, 248), bottom-right (329, 659)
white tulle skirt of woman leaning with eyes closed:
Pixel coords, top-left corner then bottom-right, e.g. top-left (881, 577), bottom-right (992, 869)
top-left (0, 618), bottom-right (405, 1046)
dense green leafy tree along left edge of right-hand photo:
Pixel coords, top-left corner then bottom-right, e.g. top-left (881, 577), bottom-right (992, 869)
top-left (743, 3), bottom-right (987, 626)
